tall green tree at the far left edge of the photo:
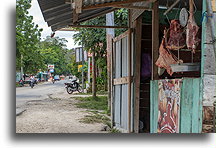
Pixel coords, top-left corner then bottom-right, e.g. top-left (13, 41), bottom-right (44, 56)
top-left (16, 0), bottom-right (43, 74)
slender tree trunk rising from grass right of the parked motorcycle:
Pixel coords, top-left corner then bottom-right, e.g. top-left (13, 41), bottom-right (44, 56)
top-left (92, 51), bottom-right (97, 97)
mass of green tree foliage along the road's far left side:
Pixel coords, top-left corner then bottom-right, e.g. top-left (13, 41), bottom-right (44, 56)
top-left (16, 0), bottom-right (72, 74)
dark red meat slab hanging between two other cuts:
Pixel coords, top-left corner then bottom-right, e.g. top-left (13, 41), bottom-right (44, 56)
top-left (167, 20), bottom-right (185, 50)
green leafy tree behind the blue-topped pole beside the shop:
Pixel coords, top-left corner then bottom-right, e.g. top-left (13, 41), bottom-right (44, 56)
top-left (73, 9), bottom-right (128, 96)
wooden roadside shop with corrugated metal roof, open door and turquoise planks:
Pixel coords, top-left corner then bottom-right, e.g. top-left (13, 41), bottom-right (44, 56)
top-left (38, 0), bottom-right (216, 133)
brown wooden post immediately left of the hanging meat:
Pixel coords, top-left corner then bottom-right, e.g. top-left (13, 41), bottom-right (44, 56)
top-left (152, 1), bottom-right (159, 80)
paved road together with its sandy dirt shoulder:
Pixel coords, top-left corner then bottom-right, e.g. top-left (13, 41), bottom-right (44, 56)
top-left (16, 80), bottom-right (107, 133)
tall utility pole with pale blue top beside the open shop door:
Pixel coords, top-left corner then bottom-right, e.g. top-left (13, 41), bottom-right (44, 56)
top-left (106, 12), bottom-right (115, 110)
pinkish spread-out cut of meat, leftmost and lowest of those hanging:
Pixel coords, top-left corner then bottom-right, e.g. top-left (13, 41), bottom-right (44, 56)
top-left (155, 29), bottom-right (177, 75)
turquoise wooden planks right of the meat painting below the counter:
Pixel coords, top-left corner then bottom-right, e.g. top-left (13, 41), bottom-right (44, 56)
top-left (180, 78), bottom-right (202, 133)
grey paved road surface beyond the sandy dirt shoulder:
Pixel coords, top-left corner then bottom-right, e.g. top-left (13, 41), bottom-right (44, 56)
top-left (16, 80), bottom-right (68, 114)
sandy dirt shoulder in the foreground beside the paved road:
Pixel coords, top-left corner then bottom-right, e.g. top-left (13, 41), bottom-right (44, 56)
top-left (16, 94), bottom-right (107, 133)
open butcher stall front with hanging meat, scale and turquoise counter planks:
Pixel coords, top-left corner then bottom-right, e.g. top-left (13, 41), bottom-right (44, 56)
top-left (132, 0), bottom-right (216, 133)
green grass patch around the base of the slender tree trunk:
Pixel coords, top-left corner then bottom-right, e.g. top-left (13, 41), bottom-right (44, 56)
top-left (75, 96), bottom-right (108, 111)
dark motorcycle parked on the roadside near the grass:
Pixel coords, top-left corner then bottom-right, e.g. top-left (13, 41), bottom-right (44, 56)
top-left (64, 80), bottom-right (82, 94)
